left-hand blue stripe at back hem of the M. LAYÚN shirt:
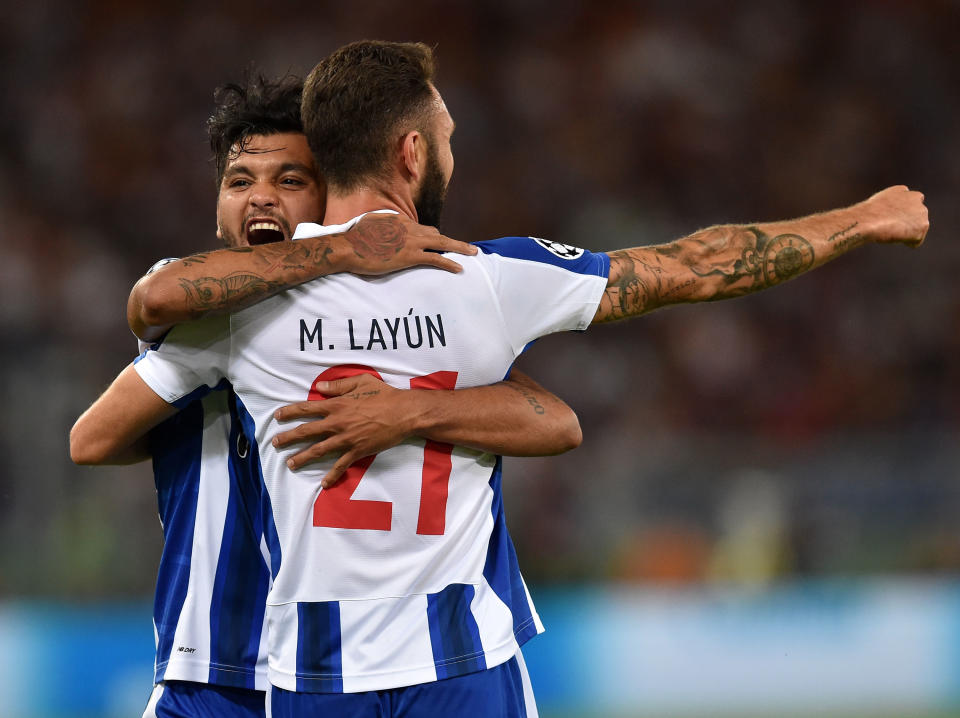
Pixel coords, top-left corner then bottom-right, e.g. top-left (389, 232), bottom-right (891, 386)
top-left (297, 601), bottom-right (343, 693)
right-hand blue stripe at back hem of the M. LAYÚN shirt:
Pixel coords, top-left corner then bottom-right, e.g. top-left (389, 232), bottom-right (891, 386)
top-left (427, 583), bottom-right (487, 680)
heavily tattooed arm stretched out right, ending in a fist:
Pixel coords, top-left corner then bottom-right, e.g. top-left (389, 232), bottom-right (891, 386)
top-left (593, 186), bottom-right (929, 323)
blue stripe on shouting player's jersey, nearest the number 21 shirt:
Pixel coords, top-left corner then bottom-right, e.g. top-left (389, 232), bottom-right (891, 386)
top-left (210, 392), bottom-right (270, 689)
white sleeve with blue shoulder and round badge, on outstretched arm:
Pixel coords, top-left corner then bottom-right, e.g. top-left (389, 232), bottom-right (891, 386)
top-left (476, 237), bottom-right (610, 351)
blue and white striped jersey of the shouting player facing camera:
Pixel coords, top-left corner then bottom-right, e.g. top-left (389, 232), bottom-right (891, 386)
top-left (140, 260), bottom-right (270, 690)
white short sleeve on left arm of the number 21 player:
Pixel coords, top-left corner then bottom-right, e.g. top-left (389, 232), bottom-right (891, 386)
top-left (134, 315), bottom-right (230, 406)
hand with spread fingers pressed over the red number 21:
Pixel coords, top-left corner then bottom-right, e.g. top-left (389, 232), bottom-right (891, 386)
top-left (273, 374), bottom-right (418, 489)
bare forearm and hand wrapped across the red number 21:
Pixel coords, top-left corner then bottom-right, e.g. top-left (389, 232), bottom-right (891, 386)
top-left (273, 371), bottom-right (582, 488)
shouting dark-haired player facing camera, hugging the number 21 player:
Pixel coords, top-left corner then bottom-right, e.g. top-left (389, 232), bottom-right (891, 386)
top-left (71, 77), bottom-right (579, 717)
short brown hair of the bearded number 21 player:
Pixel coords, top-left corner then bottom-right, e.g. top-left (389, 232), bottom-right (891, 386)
top-left (302, 40), bottom-right (434, 191)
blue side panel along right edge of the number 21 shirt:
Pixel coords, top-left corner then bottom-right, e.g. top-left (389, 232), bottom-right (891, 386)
top-left (483, 464), bottom-right (537, 646)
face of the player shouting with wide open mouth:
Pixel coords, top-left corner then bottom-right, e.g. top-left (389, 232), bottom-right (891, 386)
top-left (217, 132), bottom-right (326, 247)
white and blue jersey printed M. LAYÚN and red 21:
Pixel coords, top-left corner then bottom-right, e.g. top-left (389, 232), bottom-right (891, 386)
top-left (136, 220), bottom-right (609, 692)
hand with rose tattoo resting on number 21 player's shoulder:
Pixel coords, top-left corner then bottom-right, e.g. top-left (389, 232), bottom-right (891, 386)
top-left (343, 213), bottom-right (477, 275)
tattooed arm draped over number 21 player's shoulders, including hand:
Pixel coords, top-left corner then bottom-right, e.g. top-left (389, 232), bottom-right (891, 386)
top-left (127, 214), bottom-right (476, 341)
